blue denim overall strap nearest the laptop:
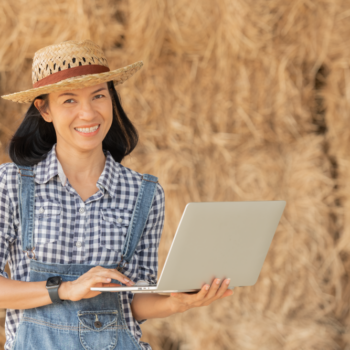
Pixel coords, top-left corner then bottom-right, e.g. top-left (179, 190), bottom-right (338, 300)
top-left (118, 174), bottom-right (158, 269)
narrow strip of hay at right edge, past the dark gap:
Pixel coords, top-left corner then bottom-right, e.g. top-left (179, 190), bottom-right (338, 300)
top-left (319, 6), bottom-right (350, 350)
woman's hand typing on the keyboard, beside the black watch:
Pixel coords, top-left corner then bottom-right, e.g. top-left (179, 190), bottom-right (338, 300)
top-left (58, 266), bottom-right (135, 301)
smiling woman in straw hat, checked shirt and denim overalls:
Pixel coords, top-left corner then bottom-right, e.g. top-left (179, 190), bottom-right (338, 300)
top-left (0, 41), bottom-right (232, 350)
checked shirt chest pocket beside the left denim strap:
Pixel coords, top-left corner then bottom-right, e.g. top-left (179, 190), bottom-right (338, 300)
top-left (34, 201), bottom-right (62, 245)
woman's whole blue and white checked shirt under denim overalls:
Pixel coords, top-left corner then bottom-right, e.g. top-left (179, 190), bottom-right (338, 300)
top-left (0, 146), bottom-right (164, 350)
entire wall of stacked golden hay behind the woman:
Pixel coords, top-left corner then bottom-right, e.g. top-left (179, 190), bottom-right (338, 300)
top-left (0, 0), bottom-right (350, 350)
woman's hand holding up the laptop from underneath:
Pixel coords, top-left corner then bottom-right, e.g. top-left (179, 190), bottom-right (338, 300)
top-left (168, 278), bottom-right (233, 313)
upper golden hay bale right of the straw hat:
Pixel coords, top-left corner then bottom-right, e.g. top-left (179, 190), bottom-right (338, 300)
top-left (126, 0), bottom-right (340, 142)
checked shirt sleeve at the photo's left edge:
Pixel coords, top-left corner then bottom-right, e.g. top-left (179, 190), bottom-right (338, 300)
top-left (0, 163), bottom-right (16, 278)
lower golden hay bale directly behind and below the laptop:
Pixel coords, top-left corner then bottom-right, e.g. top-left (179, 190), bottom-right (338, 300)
top-left (134, 136), bottom-right (342, 349)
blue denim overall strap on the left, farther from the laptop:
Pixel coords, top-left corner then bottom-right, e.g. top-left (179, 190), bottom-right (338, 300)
top-left (15, 164), bottom-right (35, 260)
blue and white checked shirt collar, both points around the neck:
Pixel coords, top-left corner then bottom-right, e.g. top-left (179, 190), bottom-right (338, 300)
top-left (35, 144), bottom-right (122, 197)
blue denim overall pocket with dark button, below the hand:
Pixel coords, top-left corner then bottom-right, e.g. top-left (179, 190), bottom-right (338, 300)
top-left (78, 310), bottom-right (118, 350)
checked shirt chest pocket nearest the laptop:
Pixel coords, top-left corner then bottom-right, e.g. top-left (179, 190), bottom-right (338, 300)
top-left (100, 209), bottom-right (132, 252)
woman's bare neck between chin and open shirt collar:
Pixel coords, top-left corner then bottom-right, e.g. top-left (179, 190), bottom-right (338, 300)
top-left (56, 142), bottom-right (106, 183)
